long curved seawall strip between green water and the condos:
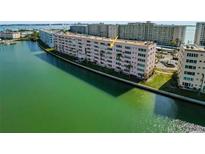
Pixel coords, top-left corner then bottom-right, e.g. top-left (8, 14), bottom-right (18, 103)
top-left (38, 42), bottom-right (205, 106)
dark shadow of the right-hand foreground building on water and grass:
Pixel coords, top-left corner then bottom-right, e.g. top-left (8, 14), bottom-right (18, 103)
top-left (154, 77), bottom-right (205, 126)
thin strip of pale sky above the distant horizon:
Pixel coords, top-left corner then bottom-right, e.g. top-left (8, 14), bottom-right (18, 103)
top-left (0, 21), bottom-right (196, 25)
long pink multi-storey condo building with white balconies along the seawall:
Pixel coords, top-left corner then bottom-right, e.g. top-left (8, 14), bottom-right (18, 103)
top-left (54, 33), bottom-right (156, 79)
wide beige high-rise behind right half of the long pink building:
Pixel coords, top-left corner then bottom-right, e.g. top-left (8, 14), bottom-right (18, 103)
top-left (119, 22), bottom-right (186, 46)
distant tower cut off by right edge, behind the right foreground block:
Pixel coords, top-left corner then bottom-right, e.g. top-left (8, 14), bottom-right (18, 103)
top-left (194, 22), bottom-right (205, 46)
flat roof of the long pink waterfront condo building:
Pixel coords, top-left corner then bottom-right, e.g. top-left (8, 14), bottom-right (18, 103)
top-left (56, 32), bottom-right (155, 47)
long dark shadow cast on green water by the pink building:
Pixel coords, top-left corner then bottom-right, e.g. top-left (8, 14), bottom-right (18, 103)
top-left (35, 53), bottom-right (134, 97)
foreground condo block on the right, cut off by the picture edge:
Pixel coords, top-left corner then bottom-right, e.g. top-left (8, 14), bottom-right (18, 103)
top-left (178, 45), bottom-right (205, 93)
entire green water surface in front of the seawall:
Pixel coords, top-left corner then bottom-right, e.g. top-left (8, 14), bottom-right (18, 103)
top-left (0, 42), bottom-right (205, 132)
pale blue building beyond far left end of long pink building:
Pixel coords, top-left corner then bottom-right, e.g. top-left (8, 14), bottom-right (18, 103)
top-left (39, 30), bottom-right (56, 48)
